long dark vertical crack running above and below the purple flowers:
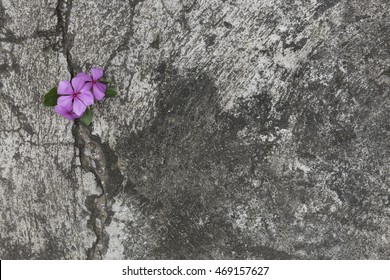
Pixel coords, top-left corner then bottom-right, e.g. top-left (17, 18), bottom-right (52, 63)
top-left (56, 0), bottom-right (125, 259)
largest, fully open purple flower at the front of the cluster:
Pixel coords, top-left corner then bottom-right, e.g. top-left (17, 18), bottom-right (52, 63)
top-left (56, 77), bottom-right (93, 116)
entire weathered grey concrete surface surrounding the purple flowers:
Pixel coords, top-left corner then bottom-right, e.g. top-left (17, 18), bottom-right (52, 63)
top-left (0, 0), bottom-right (390, 259)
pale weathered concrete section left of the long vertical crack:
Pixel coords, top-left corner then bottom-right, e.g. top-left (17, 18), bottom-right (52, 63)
top-left (0, 1), bottom-right (98, 259)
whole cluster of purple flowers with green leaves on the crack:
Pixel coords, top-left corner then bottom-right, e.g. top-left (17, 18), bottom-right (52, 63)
top-left (43, 68), bottom-right (116, 125)
